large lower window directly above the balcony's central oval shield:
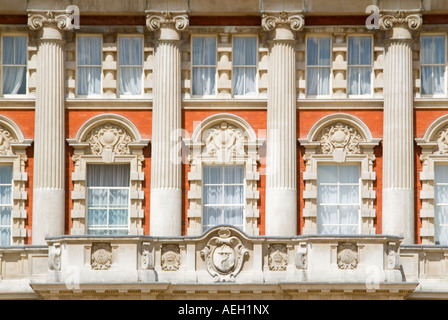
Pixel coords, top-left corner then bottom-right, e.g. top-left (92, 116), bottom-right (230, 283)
top-left (203, 166), bottom-right (244, 231)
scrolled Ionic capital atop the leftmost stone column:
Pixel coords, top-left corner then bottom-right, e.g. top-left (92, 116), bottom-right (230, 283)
top-left (28, 10), bottom-right (72, 31)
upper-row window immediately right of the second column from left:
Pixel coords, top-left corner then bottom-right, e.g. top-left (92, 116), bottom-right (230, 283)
top-left (193, 37), bottom-right (216, 95)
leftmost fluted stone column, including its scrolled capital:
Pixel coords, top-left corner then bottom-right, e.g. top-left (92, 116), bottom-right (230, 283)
top-left (28, 10), bottom-right (70, 245)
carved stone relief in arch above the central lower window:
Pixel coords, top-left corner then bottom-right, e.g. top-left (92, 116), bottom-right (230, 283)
top-left (202, 122), bottom-right (247, 161)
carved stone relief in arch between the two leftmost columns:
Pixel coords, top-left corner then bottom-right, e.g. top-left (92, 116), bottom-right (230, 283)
top-left (86, 123), bottom-right (133, 162)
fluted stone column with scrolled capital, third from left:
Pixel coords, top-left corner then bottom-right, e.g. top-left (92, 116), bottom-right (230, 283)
top-left (262, 12), bottom-right (304, 236)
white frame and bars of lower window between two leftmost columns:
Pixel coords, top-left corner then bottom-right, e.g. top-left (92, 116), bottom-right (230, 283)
top-left (86, 163), bottom-right (131, 235)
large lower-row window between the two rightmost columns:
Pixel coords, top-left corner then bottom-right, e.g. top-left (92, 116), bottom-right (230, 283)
top-left (318, 165), bottom-right (360, 234)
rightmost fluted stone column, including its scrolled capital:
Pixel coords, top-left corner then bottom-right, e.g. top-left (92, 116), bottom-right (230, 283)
top-left (380, 11), bottom-right (422, 244)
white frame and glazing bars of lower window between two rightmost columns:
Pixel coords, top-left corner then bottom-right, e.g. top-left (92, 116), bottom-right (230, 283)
top-left (317, 161), bottom-right (362, 235)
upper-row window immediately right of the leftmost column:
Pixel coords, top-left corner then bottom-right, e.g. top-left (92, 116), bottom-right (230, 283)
top-left (76, 36), bottom-right (102, 95)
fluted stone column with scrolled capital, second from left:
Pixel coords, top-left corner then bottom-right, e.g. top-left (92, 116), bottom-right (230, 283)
top-left (146, 11), bottom-right (188, 236)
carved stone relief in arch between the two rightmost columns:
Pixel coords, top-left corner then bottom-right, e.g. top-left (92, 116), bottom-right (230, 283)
top-left (318, 122), bottom-right (363, 154)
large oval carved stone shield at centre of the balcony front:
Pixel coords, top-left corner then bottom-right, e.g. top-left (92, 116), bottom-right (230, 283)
top-left (201, 227), bottom-right (249, 282)
